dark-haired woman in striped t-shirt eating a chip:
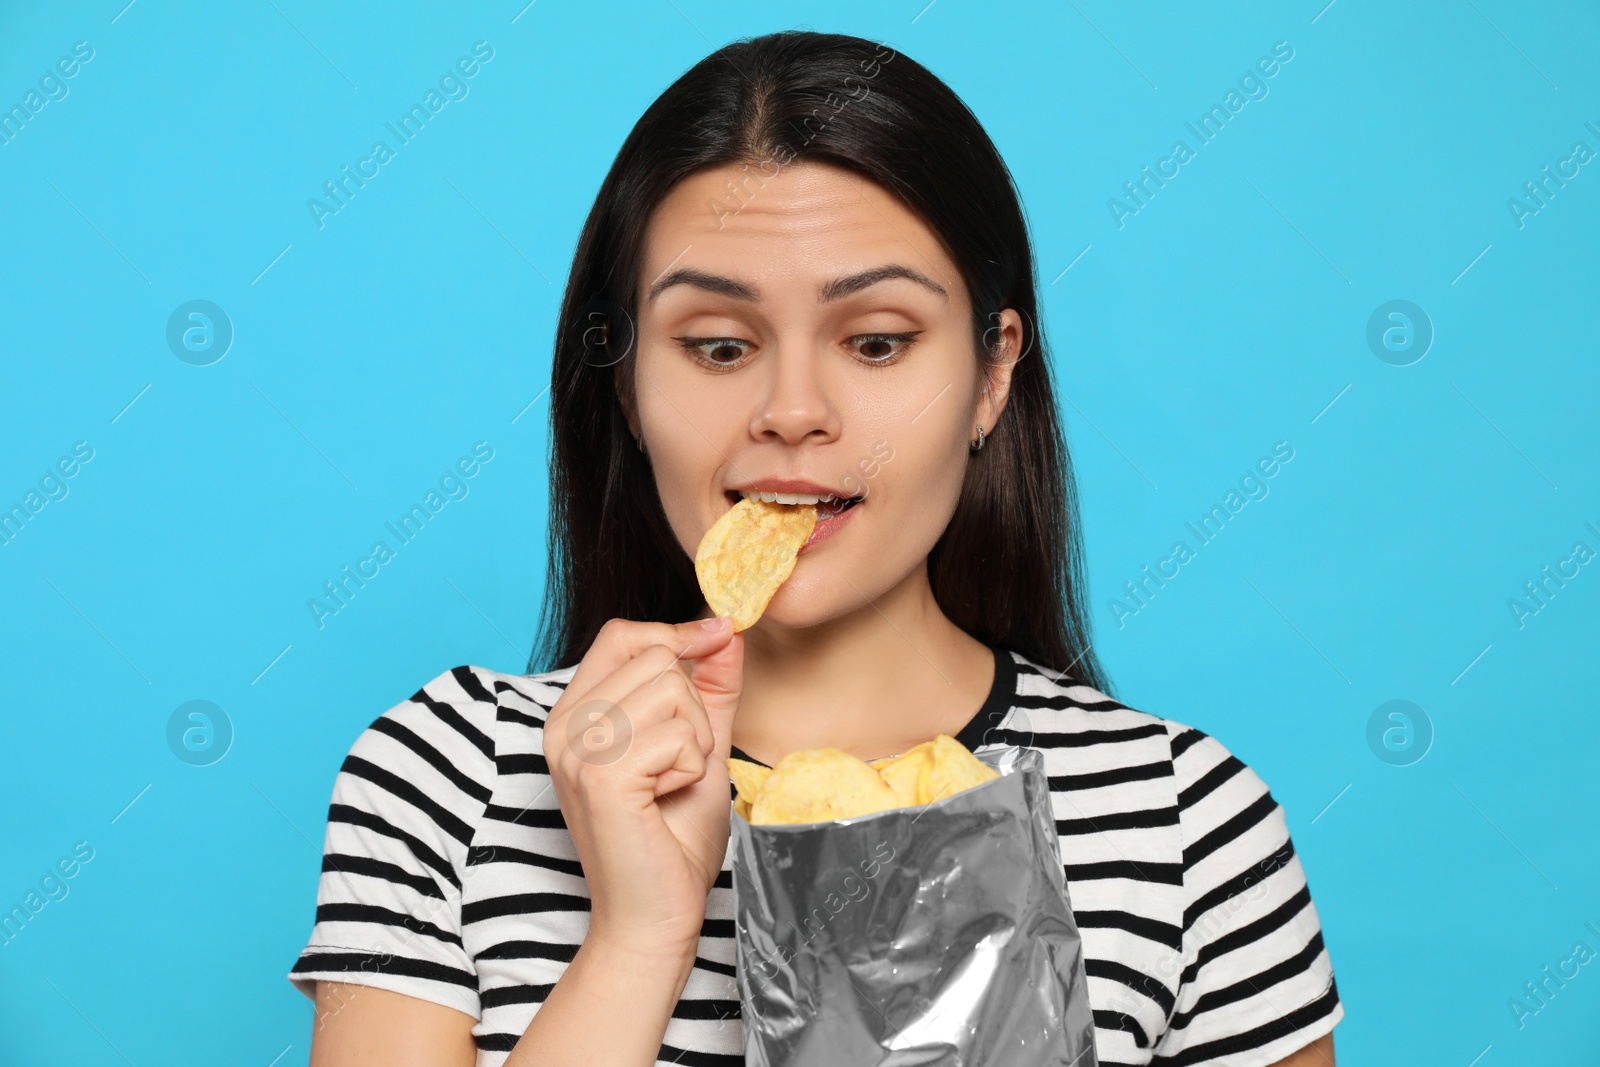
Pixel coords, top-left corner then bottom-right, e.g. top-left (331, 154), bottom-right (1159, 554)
top-left (290, 32), bottom-right (1344, 1067)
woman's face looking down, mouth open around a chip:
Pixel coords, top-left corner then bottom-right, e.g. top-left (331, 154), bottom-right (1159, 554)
top-left (635, 154), bottom-right (1019, 627)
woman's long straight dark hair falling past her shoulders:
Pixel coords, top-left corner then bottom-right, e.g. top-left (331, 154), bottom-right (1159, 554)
top-left (528, 30), bottom-right (1107, 691)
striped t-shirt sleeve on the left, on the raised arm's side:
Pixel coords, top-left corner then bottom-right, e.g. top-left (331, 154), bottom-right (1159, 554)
top-left (288, 667), bottom-right (496, 1019)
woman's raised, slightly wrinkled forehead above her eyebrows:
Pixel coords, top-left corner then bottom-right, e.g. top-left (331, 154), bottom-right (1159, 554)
top-left (638, 162), bottom-right (963, 304)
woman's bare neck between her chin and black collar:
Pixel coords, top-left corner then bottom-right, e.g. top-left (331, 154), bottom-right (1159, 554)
top-left (729, 561), bottom-right (994, 765)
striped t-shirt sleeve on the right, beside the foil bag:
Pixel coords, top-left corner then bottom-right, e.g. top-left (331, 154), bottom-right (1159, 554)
top-left (1152, 723), bottom-right (1344, 1067)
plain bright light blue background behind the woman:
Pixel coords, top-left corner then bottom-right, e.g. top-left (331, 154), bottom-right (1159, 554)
top-left (0, 0), bottom-right (1600, 1067)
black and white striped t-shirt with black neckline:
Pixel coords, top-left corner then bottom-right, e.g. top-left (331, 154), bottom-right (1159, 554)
top-left (288, 649), bottom-right (1344, 1067)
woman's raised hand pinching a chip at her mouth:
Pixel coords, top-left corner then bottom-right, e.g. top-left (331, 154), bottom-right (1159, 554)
top-left (544, 619), bottom-right (744, 960)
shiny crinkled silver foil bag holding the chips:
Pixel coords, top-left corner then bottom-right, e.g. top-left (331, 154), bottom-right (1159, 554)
top-left (731, 745), bottom-right (1098, 1067)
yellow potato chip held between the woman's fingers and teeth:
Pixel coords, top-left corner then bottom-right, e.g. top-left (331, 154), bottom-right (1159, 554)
top-left (694, 498), bottom-right (816, 633)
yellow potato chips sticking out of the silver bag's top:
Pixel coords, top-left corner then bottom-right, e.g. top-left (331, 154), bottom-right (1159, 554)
top-left (728, 734), bottom-right (1000, 825)
